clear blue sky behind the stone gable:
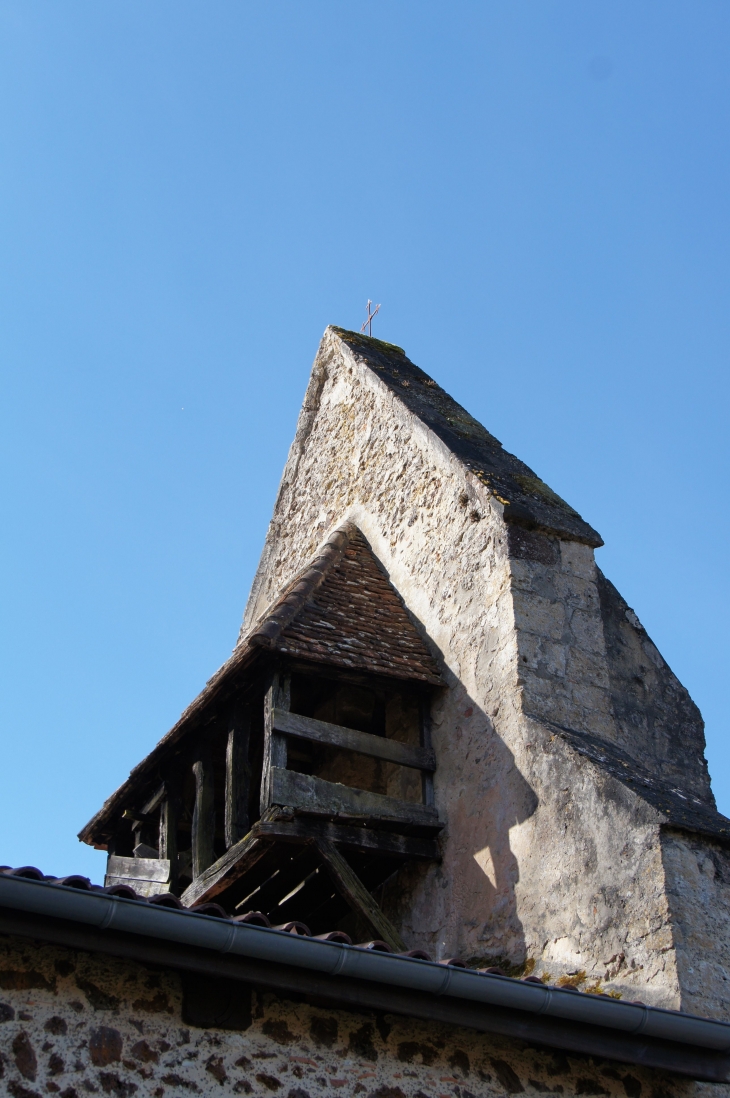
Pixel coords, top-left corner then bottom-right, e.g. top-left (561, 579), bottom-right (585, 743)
top-left (0, 0), bottom-right (730, 879)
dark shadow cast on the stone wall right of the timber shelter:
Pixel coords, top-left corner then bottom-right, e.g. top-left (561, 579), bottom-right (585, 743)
top-left (382, 684), bottom-right (539, 975)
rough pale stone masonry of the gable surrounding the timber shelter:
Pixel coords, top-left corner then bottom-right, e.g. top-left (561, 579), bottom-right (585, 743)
top-left (244, 329), bottom-right (728, 1017)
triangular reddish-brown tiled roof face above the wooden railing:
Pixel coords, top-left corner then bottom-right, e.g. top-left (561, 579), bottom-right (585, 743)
top-left (248, 523), bottom-right (442, 684)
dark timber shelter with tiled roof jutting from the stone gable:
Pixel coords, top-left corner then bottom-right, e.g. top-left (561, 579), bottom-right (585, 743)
top-left (82, 526), bottom-right (442, 952)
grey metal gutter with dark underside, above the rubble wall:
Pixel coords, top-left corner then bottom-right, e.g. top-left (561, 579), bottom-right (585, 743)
top-left (0, 876), bottom-right (730, 1082)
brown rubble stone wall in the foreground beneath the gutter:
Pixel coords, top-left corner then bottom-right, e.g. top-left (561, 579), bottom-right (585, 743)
top-left (0, 938), bottom-right (702, 1098)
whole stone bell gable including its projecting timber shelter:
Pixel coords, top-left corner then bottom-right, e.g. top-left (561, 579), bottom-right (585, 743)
top-left (81, 328), bottom-right (730, 1018)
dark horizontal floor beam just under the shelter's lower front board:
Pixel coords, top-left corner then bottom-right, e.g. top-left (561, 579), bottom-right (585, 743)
top-left (251, 816), bottom-right (440, 862)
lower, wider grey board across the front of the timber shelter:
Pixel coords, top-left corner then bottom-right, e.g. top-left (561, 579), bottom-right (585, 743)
top-left (271, 766), bottom-right (442, 830)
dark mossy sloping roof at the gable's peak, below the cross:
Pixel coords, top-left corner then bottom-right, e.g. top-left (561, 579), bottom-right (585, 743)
top-left (329, 327), bottom-right (603, 547)
